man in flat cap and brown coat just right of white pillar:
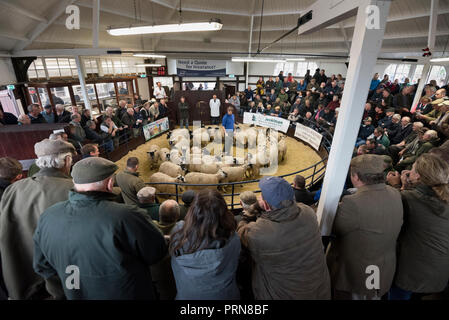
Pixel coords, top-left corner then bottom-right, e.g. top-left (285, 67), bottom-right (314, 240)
top-left (327, 154), bottom-right (403, 300)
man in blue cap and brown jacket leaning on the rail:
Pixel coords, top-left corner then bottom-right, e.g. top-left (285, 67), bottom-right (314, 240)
top-left (237, 176), bottom-right (330, 300)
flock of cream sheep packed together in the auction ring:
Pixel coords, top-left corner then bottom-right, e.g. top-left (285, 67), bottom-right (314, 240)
top-left (147, 125), bottom-right (287, 194)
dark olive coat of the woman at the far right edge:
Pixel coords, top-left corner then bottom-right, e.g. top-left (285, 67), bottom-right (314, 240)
top-left (394, 185), bottom-right (449, 293)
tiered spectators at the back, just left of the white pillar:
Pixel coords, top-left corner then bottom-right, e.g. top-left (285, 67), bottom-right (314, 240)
top-left (226, 69), bottom-right (345, 132)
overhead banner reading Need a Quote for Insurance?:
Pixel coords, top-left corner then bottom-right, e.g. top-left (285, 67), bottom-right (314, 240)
top-left (176, 59), bottom-right (226, 77)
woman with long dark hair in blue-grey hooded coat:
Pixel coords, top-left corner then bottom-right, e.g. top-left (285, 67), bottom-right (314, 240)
top-left (170, 189), bottom-right (241, 300)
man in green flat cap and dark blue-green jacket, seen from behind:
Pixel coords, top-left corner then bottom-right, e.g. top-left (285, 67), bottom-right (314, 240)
top-left (34, 157), bottom-right (167, 300)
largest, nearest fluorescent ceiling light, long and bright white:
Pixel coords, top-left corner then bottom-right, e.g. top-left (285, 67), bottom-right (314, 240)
top-left (107, 21), bottom-right (223, 36)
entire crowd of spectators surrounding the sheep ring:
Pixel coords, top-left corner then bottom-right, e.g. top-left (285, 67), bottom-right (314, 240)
top-left (0, 70), bottom-right (449, 300)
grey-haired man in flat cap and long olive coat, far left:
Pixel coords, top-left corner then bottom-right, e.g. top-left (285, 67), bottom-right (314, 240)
top-left (0, 139), bottom-right (75, 299)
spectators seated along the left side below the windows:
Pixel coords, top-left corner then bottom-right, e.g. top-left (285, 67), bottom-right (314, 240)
top-left (0, 93), bottom-right (168, 157)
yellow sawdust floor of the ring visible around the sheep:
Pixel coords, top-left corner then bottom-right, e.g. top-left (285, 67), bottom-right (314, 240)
top-left (116, 134), bottom-right (324, 208)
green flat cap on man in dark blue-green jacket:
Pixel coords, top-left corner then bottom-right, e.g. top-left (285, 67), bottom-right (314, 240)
top-left (72, 157), bottom-right (118, 184)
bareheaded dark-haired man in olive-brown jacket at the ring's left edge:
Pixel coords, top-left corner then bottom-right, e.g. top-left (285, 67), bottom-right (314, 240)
top-left (116, 157), bottom-right (145, 206)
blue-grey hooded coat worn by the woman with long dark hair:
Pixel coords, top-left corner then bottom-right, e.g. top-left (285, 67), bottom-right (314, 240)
top-left (171, 221), bottom-right (241, 300)
